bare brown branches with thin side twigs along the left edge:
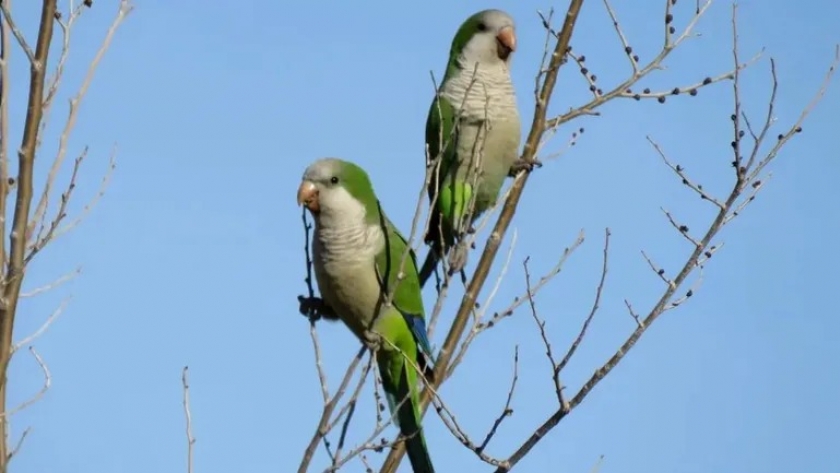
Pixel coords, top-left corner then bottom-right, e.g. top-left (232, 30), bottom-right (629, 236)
top-left (0, 0), bottom-right (133, 464)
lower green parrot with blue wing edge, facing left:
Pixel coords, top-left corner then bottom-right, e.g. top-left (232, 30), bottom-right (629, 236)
top-left (297, 158), bottom-right (435, 473)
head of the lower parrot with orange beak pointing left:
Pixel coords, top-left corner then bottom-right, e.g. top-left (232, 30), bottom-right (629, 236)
top-left (297, 158), bottom-right (377, 218)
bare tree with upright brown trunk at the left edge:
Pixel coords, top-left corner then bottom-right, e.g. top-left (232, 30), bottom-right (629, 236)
top-left (0, 0), bottom-right (133, 473)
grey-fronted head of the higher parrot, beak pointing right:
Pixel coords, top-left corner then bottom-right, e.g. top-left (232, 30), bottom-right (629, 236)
top-left (449, 10), bottom-right (516, 69)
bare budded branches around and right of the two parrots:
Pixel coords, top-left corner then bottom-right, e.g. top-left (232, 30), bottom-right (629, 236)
top-left (299, 0), bottom-right (840, 473)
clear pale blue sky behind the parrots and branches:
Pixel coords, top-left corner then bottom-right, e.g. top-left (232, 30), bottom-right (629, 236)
top-left (10, 0), bottom-right (840, 473)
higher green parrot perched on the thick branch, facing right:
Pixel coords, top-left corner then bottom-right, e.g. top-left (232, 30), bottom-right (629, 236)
top-left (420, 10), bottom-right (533, 287)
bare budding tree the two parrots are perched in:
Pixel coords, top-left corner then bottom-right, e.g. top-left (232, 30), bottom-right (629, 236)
top-left (288, 0), bottom-right (840, 473)
